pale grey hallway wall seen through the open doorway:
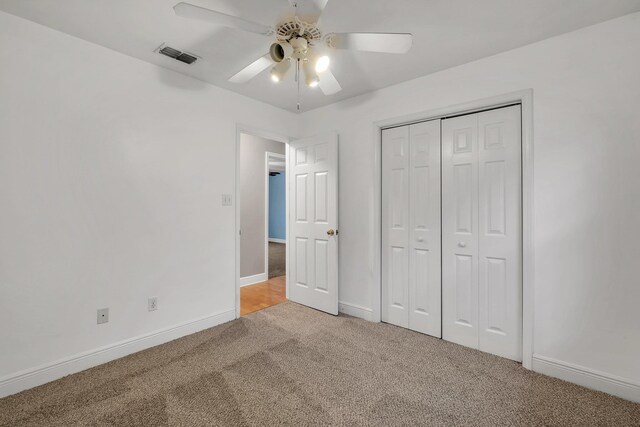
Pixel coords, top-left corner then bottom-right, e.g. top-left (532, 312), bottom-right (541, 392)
top-left (239, 133), bottom-right (285, 280)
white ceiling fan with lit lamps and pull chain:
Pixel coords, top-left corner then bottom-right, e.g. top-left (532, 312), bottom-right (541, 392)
top-left (173, 0), bottom-right (413, 109)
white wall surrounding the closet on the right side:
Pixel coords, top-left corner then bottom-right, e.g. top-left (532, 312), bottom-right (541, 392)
top-left (300, 14), bottom-right (640, 392)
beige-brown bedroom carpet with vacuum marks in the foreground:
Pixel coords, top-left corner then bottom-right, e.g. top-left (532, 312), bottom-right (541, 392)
top-left (0, 302), bottom-right (640, 426)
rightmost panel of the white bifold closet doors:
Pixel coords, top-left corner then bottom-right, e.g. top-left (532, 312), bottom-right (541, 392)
top-left (478, 106), bottom-right (522, 361)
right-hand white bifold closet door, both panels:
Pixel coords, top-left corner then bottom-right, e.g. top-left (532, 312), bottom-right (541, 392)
top-left (442, 106), bottom-right (522, 361)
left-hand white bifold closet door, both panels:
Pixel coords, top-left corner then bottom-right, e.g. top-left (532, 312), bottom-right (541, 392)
top-left (382, 120), bottom-right (442, 337)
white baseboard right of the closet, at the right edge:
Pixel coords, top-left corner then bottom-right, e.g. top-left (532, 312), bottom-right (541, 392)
top-left (533, 354), bottom-right (640, 402)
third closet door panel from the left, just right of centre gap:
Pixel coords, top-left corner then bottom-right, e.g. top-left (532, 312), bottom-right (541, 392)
top-left (442, 114), bottom-right (478, 348)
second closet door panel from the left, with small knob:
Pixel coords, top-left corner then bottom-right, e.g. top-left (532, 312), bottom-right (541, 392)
top-left (409, 120), bottom-right (442, 338)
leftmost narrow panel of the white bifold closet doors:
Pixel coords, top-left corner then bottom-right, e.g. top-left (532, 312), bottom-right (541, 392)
top-left (382, 126), bottom-right (411, 328)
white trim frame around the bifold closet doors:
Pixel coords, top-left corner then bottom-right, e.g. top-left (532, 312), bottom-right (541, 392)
top-left (370, 89), bottom-right (535, 369)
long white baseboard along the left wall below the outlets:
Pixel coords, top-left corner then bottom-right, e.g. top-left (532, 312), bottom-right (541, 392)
top-left (0, 310), bottom-right (236, 398)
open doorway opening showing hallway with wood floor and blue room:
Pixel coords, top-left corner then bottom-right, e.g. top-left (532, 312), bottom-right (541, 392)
top-left (237, 132), bottom-right (287, 316)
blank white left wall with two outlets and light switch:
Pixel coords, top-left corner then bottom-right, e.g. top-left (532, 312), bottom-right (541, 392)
top-left (0, 13), bottom-right (296, 394)
